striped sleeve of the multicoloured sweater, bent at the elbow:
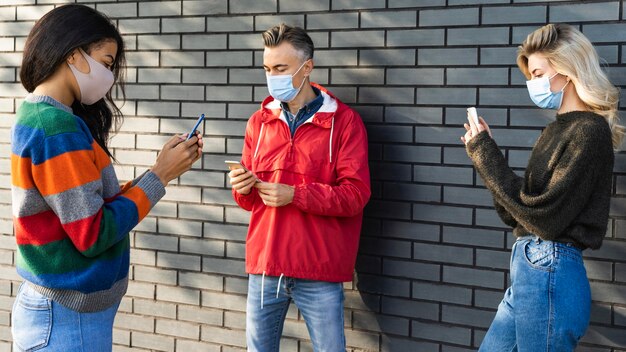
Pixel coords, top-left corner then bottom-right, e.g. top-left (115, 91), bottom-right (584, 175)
top-left (31, 133), bottom-right (165, 257)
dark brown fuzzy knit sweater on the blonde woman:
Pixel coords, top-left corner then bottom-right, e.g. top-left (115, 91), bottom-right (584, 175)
top-left (467, 111), bottom-right (614, 249)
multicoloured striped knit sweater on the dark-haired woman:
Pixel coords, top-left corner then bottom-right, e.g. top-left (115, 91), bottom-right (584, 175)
top-left (11, 94), bottom-right (165, 312)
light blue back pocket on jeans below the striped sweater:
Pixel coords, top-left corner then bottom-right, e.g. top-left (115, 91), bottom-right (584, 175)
top-left (11, 284), bottom-right (52, 352)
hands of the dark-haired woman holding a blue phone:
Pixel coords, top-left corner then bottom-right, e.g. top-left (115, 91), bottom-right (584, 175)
top-left (151, 133), bottom-right (204, 186)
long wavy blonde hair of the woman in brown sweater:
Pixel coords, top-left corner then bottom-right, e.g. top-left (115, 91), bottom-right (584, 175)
top-left (517, 23), bottom-right (624, 149)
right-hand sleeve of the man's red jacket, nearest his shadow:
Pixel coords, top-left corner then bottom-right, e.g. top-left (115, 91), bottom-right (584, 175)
top-left (293, 114), bottom-right (371, 217)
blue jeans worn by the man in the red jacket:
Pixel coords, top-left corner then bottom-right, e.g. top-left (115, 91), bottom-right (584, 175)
top-left (246, 275), bottom-right (346, 352)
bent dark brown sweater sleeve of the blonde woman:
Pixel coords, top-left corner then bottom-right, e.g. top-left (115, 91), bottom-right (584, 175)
top-left (467, 130), bottom-right (607, 240)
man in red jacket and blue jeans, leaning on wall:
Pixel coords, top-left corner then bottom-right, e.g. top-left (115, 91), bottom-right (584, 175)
top-left (229, 24), bottom-right (370, 352)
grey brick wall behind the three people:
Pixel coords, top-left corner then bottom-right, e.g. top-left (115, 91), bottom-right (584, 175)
top-left (0, 0), bottom-right (626, 352)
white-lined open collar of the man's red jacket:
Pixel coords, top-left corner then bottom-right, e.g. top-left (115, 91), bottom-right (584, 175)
top-left (261, 82), bottom-right (340, 128)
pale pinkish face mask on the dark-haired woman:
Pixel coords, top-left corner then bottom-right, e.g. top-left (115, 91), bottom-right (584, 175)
top-left (68, 48), bottom-right (115, 105)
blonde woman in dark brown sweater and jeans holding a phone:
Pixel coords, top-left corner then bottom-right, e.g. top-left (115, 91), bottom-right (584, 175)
top-left (461, 24), bottom-right (623, 352)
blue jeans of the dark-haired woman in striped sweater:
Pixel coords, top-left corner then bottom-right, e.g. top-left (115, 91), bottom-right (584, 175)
top-left (11, 283), bottom-right (119, 352)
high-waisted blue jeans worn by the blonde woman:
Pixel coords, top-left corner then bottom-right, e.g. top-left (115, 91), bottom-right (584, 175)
top-left (479, 236), bottom-right (591, 352)
